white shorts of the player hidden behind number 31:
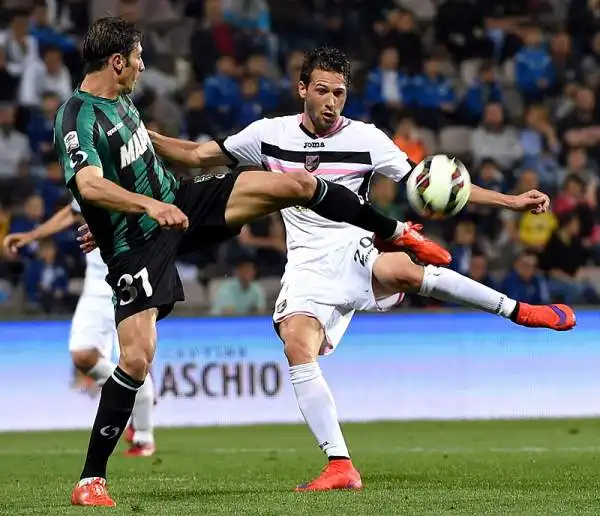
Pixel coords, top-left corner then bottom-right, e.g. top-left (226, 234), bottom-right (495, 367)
top-left (69, 294), bottom-right (119, 360)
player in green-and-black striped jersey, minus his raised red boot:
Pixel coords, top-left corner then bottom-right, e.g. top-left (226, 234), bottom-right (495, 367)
top-left (59, 18), bottom-right (426, 506)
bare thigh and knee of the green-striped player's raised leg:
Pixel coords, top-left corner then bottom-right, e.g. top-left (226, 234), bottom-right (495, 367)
top-left (225, 171), bottom-right (316, 226)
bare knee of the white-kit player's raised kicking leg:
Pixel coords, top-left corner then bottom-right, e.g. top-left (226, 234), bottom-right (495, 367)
top-left (372, 252), bottom-right (423, 298)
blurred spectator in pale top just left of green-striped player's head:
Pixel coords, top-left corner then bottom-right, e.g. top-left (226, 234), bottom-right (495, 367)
top-left (19, 47), bottom-right (73, 107)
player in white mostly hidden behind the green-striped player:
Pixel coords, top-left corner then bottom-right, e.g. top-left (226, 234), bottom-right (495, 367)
top-left (4, 200), bottom-right (155, 457)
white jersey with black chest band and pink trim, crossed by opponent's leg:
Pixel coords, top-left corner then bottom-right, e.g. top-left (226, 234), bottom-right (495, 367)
top-left (223, 115), bottom-right (411, 271)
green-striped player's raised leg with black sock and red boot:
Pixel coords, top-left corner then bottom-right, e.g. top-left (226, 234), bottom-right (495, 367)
top-left (225, 171), bottom-right (452, 265)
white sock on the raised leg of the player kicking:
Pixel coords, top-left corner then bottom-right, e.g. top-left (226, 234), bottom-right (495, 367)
top-left (419, 265), bottom-right (517, 318)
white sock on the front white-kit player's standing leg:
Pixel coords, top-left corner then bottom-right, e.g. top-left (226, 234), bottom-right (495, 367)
top-left (290, 362), bottom-right (350, 457)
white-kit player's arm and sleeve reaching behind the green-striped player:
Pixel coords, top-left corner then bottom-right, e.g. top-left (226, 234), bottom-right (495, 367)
top-left (148, 119), bottom-right (268, 168)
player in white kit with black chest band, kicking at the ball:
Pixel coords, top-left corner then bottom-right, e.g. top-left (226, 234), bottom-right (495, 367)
top-left (125, 48), bottom-right (575, 490)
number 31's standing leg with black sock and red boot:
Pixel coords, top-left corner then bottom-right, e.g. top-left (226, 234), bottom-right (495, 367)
top-left (71, 308), bottom-right (157, 507)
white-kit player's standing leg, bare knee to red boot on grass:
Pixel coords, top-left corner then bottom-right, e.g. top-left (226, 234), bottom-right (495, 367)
top-left (279, 315), bottom-right (362, 491)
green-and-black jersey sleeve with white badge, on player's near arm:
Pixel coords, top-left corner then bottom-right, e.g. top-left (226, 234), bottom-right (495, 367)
top-left (54, 98), bottom-right (102, 185)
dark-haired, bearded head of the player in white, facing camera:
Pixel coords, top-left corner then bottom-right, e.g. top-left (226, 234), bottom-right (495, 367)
top-left (298, 47), bottom-right (350, 133)
